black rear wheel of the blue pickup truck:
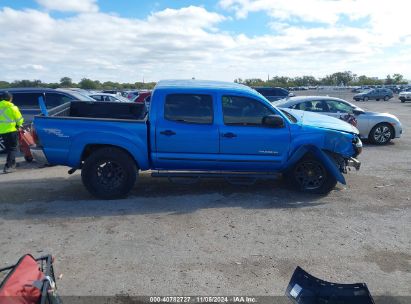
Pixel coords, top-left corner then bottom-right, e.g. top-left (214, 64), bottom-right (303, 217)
top-left (81, 147), bottom-right (137, 199)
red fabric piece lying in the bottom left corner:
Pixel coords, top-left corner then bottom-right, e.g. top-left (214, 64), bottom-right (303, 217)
top-left (0, 254), bottom-right (44, 304)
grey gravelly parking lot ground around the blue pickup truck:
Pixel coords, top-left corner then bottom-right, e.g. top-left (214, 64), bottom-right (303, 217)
top-left (0, 91), bottom-right (411, 296)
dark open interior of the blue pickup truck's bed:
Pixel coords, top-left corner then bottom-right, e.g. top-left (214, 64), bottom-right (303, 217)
top-left (47, 101), bottom-right (147, 121)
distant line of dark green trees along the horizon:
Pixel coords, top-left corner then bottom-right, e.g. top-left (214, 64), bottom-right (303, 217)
top-left (0, 71), bottom-right (408, 90)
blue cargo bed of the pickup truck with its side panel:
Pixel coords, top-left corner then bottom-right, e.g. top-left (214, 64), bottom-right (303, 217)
top-left (34, 101), bottom-right (149, 168)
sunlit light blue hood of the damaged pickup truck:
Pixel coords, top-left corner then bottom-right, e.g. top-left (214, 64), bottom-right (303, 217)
top-left (282, 109), bottom-right (359, 134)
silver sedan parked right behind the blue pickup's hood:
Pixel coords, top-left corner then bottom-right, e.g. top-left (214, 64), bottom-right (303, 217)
top-left (273, 96), bottom-right (402, 145)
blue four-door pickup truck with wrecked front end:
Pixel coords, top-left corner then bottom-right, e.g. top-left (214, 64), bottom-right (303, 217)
top-left (32, 80), bottom-right (362, 199)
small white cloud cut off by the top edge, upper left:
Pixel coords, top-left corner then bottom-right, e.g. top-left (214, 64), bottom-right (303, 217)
top-left (36, 0), bottom-right (98, 13)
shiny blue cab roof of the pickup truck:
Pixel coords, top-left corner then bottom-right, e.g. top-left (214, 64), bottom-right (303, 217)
top-left (155, 79), bottom-right (258, 95)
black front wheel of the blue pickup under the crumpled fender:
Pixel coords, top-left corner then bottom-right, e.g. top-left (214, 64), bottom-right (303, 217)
top-left (285, 156), bottom-right (337, 194)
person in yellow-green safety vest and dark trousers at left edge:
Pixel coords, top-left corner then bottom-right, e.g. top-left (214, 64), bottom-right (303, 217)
top-left (0, 92), bottom-right (24, 173)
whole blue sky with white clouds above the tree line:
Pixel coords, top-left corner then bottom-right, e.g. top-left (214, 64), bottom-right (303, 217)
top-left (0, 0), bottom-right (411, 83)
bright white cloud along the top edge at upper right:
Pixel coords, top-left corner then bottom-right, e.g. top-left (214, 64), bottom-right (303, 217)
top-left (219, 0), bottom-right (410, 45)
